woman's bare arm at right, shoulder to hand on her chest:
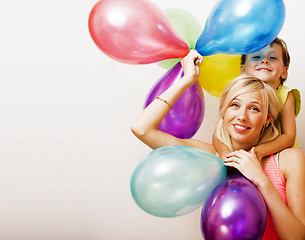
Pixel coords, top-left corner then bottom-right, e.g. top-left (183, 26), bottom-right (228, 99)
top-left (225, 148), bottom-right (305, 240)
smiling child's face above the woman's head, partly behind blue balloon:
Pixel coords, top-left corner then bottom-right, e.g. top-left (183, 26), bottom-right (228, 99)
top-left (241, 44), bottom-right (287, 89)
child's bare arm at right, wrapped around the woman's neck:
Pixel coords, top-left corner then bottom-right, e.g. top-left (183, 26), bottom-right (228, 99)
top-left (255, 92), bottom-right (296, 160)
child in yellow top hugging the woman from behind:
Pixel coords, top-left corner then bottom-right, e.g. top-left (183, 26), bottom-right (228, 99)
top-left (213, 38), bottom-right (301, 159)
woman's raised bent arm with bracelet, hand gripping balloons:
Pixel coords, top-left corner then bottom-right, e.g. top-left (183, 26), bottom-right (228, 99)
top-left (131, 50), bottom-right (215, 154)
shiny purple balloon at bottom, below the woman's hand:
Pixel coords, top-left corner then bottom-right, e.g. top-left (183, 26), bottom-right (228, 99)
top-left (201, 173), bottom-right (267, 240)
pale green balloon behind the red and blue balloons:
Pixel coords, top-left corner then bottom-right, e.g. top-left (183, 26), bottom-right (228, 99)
top-left (158, 8), bottom-right (202, 69)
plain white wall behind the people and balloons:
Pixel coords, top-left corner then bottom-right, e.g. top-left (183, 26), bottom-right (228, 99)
top-left (0, 0), bottom-right (305, 240)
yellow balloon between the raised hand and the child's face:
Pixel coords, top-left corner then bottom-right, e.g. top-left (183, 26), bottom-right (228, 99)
top-left (198, 54), bottom-right (241, 97)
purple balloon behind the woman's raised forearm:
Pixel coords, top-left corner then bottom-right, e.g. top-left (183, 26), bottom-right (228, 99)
top-left (145, 62), bottom-right (205, 138)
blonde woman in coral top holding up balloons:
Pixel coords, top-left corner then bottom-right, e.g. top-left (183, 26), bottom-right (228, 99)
top-left (131, 50), bottom-right (305, 240)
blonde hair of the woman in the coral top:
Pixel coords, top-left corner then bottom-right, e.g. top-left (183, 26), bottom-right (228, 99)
top-left (215, 74), bottom-right (280, 151)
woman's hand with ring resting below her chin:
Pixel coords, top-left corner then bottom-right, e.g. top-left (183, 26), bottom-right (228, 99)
top-left (224, 147), bottom-right (268, 186)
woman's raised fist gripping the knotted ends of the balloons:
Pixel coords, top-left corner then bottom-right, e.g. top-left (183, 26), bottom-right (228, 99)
top-left (180, 49), bottom-right (203, 83)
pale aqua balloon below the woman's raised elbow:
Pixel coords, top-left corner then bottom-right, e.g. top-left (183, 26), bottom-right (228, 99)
top-left (130, 146), bottom-right (227, 217)
